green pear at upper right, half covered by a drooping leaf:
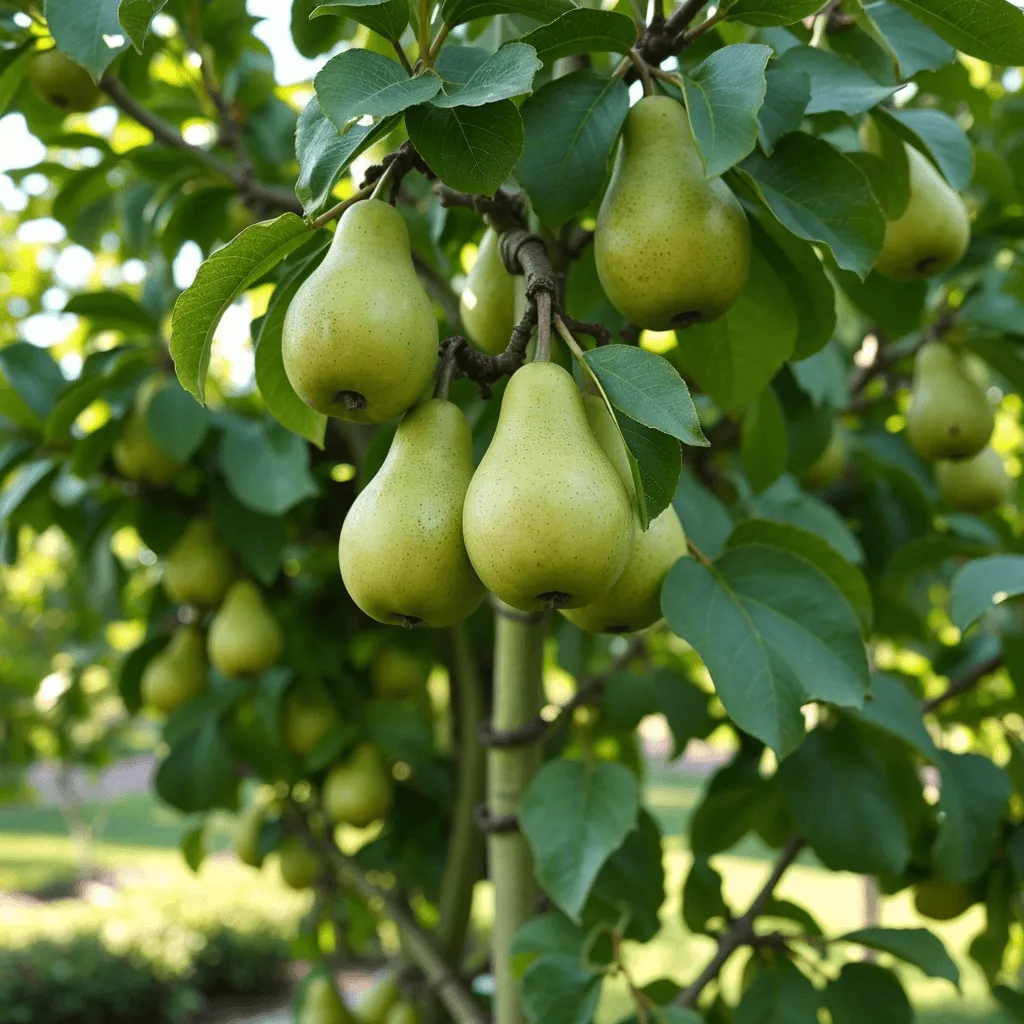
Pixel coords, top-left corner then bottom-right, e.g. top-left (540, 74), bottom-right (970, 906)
top-left (874, 146), bottom-right (971, 281)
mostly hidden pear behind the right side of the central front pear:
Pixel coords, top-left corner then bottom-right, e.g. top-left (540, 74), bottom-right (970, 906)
top-left (562, 394), bottom-right (686, 633)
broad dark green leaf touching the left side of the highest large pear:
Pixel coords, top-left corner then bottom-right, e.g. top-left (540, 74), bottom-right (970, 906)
top-left (516, 70), bottom-right (630, 227)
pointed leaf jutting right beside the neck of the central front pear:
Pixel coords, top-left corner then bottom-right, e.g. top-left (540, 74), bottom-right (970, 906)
top-left (586, 345), bottom-right (708, 448)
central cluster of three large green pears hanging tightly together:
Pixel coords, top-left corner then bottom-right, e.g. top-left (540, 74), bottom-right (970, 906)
top-left (339, 361), bottom-right (686, 632)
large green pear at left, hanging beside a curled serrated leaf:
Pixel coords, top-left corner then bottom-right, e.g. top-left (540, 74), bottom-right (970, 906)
top-left (281, 200), bottom-right (437, 423)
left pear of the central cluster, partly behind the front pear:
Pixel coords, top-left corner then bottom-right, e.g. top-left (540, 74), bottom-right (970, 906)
top-left (338, 398), bottom-right (483, 626)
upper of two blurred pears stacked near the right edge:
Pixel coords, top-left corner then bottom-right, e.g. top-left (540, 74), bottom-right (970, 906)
top-left (906, 341), bottom-right (995, 460)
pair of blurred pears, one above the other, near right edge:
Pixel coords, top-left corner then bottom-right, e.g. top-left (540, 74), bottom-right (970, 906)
top-left (906, 341), bottom-right (1012, 512)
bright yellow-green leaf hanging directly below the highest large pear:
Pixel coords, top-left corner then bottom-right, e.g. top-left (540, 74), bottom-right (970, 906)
top-left (671, 241), bottom-right (799, 410)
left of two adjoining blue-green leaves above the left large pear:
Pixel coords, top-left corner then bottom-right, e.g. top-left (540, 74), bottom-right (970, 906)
top-left (313, 47), bottom-right (441, 132)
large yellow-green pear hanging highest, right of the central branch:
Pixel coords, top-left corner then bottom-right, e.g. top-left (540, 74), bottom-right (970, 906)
top-left (594, 96), bottom-right (751, 331)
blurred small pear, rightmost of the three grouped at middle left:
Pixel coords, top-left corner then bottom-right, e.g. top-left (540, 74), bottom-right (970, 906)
top-left (207, 580), bottom-right (284, 676)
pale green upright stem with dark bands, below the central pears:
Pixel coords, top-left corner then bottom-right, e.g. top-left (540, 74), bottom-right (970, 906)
top-left (487, 606), bottom-right (547, 1024)
